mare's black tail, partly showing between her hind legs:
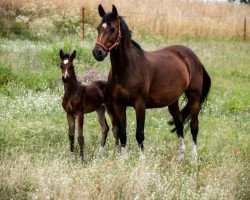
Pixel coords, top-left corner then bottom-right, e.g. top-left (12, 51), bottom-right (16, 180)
top-left (168, 65), bottom-right (211, 132)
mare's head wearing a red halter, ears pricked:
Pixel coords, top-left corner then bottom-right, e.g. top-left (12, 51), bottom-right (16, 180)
top-left (93, 4), bottom-right (121, 61)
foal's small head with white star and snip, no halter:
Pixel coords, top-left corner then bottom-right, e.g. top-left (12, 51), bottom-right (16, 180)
top-left (59, 49), bottom-right (76, 83)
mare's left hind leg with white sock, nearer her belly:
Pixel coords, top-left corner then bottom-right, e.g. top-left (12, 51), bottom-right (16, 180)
top-left (168, 101), bottom-right (185, 160)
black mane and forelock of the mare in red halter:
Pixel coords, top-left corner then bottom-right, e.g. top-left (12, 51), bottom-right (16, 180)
top-left (103, 12), bottom-right (143, 55)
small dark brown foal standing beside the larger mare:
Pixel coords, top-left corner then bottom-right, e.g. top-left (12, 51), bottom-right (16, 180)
top-left (59, 50), bottom-right (119, 162)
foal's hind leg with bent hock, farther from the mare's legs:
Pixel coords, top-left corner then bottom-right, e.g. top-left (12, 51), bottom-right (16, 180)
top-left (96, 106), bottom-right (109, 149)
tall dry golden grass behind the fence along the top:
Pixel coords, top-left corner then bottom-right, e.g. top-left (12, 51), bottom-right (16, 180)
top-left (0, 0), bottom-right (250, 38)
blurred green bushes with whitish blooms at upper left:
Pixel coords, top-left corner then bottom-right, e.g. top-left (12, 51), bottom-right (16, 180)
top-left (0, 3), bottom-right (82, 40)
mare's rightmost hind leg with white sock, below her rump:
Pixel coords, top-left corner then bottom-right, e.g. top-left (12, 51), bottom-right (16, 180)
top-left (188, 93), bottom-right (200, 160)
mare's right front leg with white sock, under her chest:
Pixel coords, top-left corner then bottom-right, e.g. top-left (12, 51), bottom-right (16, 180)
top-left (135, 99), bottom-right (146, 160)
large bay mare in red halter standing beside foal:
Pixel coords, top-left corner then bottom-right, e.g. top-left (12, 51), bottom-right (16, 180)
top-left (92, 5), bottom-right (211, 160)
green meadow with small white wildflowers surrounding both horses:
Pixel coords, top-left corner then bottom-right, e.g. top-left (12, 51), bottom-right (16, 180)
top-left (0, 0), bottom-right (250, 200)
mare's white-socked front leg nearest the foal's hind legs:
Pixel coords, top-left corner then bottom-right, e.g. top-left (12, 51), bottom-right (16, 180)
top-left (113, 102), bottom-right (128, 160)
